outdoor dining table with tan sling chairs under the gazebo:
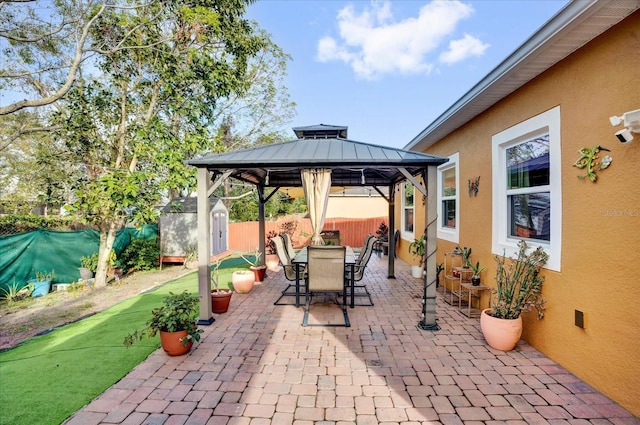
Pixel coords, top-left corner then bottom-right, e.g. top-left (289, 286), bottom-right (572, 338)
top-left (271, 233), bottom-right (377, 327)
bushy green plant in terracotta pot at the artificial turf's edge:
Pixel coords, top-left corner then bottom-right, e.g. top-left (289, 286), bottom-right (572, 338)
top-left (124, 290), bottom-right (203, 356)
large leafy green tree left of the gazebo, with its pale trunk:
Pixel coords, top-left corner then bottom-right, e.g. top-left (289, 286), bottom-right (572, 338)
top-left (0, 0), bottom-right (294, 285)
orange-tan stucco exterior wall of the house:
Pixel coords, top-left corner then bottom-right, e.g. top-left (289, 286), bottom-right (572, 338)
top-left (398, 12), bottom-right (640, 416)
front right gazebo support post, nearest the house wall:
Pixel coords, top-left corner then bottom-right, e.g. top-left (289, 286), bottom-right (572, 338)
top-left (418, 167), bottom-right (440, 331)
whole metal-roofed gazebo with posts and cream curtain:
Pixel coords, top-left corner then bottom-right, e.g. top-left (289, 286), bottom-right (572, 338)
top-left (187, 124), bottom-right (447, 330)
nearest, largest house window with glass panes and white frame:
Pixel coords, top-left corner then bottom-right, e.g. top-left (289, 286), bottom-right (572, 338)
top-left (492, 107), bottom-right (562, 271)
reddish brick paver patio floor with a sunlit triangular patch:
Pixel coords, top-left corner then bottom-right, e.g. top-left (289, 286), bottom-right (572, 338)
top-left (66, 256), bottom-right (640, 425)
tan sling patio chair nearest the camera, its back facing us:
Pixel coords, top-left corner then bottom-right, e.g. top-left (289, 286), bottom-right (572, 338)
top-left (302, 246), bottom-right (351, 327)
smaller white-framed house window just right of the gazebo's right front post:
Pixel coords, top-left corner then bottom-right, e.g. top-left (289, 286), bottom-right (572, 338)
top-left (437, 153), bottom-right (459, 243)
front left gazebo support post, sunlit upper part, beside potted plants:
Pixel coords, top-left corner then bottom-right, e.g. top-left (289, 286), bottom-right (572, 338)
top-left (197, 167), bottom-right (215, 325)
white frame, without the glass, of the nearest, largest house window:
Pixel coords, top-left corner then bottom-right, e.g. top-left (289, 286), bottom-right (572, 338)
top-left (491, 106), bottom-right (562, 272)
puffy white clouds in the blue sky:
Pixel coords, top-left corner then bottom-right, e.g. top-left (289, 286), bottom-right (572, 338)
top-left (316, 0), bottom-right (487, 80)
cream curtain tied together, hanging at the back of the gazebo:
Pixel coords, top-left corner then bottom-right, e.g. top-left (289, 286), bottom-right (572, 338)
top-left (301, 168), bottom-right (331, 245)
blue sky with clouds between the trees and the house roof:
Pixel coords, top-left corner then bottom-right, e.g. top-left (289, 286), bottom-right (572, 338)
top-left (247, 0), bottom-right (567, 148)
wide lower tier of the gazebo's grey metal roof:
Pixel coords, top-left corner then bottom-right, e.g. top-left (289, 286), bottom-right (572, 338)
top-left (187, 138), bottom-right (447, 187)
